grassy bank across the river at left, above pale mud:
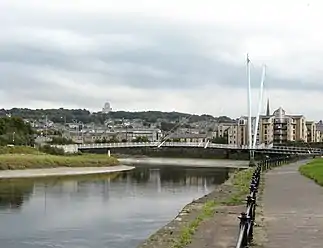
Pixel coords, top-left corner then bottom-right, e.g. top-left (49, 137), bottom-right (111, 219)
top-left (0, 147), bottom-right (119, 170)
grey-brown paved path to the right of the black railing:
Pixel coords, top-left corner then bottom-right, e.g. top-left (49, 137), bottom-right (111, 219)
top-left (263, 161), bottom-right (323, 248)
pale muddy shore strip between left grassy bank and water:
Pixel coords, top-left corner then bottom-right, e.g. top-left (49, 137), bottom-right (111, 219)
top-left (0, 165), bottom-right (135, 179)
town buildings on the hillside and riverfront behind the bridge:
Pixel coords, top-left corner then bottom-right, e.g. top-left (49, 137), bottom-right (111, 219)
top-left (8, 101), bottom-right (323, 146)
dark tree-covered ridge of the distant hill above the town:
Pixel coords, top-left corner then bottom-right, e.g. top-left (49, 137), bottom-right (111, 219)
top-left (0, 108), bottom-right (233, 123)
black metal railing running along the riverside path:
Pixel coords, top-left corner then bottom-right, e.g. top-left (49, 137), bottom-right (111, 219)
top-left (236, 156), bottom-right (299, 248)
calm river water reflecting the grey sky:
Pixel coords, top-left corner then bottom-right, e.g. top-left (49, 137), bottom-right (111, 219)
top-left (0, 159), bottom-right (244, 248)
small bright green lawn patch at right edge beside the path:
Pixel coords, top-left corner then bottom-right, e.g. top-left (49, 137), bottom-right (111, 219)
top-left (299, 158), bottom-right (323, 186)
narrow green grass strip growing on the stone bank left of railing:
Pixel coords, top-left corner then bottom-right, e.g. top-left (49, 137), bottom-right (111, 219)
top-left (172, 169), bottom-right (254, 248)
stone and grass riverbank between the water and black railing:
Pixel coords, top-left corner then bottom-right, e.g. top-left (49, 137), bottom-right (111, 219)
top-left (138, 169), bottom-right (253, 248)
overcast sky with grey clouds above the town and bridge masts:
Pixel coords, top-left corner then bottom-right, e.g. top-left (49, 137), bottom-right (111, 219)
top-left (0, 0), bottom-right (323, 120)
